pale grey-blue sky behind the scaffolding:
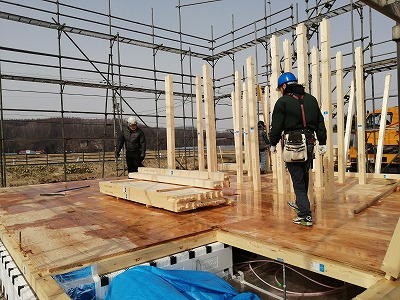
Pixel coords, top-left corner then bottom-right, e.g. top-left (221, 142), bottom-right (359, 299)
top-left (0, 0), bottom-right (397, 130)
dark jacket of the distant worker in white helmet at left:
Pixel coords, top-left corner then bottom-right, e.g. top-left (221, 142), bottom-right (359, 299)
top-left (117, 127), bottom-right (146, 157)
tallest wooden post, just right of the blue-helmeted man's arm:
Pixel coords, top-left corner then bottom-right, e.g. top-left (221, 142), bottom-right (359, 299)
top-left (317, 19), bottom-right (334, 199)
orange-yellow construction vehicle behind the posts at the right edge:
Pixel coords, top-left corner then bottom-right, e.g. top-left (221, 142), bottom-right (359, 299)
top-left (347, 106), bottom-right (400, 174)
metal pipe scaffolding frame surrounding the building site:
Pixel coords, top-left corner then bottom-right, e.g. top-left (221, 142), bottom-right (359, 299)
top-left (0, 0), bottom-right (397, 186)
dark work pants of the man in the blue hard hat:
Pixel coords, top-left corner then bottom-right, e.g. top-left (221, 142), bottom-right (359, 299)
top-left (286, 161), bottom-right (311, 218)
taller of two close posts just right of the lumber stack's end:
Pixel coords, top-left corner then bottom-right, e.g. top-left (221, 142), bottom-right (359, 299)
top-left (232, 71), bottom-right (243, 184)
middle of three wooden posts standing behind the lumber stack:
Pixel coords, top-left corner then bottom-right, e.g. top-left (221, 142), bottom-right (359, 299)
top-left (196, 75), bottom-right (205, 171)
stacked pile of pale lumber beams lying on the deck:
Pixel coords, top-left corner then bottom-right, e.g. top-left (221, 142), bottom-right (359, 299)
top-left (99, 168), bottom-right (230, 212)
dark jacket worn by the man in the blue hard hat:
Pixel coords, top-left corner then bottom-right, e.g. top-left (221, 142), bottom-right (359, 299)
top-left (270, 84), bottom-right (326, 146)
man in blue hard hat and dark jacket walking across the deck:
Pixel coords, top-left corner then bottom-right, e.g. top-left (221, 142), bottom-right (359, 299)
top-left (270, 72), bottom-right (327, 226)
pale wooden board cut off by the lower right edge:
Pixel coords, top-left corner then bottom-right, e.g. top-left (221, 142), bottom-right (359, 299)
top-left (381, 218), bottom-right (400, 279)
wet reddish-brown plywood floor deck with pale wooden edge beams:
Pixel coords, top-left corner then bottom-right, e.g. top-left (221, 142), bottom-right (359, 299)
top-left (0, 174), bottom-right (400, 299)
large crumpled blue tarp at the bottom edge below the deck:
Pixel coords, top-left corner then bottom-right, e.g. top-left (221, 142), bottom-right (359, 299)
top-left (106, 266), bottom-right (260, 300)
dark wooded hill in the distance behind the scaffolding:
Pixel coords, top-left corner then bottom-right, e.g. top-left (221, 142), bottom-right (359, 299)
top-left (3, 118), bottom-right (233, 153)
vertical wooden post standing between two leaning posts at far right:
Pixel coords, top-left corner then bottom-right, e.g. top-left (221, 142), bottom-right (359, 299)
top-left (355, 47), bottom-right (367, 184)
